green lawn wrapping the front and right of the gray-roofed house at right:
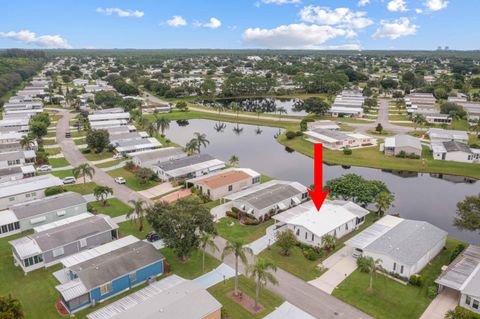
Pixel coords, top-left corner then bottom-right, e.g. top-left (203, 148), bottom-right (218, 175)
top-left (333, 238), bottom-right (459, 319)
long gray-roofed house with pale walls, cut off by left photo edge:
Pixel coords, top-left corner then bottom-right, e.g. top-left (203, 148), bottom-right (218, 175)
top-left (0, 192), bottom-right (87, 237)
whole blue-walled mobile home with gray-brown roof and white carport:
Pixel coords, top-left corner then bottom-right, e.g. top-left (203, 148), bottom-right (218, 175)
top-left (56, 236), bottom-right (165, 313)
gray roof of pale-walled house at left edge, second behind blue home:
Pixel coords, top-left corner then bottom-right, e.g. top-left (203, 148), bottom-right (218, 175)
top-left (10, 192), bottom-right (87, 219)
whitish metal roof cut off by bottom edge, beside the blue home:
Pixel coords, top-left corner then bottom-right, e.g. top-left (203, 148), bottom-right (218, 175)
top-left (87, 275), bottom-right (222, 319)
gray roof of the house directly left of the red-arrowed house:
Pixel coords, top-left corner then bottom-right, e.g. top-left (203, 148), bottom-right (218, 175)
top-left (237, 184), bottom-right (302, 210)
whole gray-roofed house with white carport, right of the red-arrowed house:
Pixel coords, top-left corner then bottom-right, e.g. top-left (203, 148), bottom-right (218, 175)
top-left (345, 215), bottom-right (448, 278)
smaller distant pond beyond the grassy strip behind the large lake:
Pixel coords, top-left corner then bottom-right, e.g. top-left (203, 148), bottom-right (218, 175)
top-left (199, 98), bottom-right (307, 116)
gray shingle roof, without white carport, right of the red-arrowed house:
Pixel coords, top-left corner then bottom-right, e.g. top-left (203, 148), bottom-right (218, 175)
top-left (365, 220), bottom-right (447, 265)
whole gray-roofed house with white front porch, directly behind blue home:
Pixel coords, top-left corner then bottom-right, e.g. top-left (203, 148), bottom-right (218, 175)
top-left (9, 213), bottom-right (118, 273)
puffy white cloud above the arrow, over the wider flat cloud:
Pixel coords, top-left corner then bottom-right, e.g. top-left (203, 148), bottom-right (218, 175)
top-left (299, 6), bottom-right (373, 29)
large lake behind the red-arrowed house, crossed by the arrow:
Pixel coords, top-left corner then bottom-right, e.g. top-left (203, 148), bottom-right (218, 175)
top-left (166, 120), bottom-right (480, 243)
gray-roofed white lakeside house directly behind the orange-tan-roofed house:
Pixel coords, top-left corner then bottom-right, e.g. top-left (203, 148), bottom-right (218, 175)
top-left (151, 154), bottom-right (225, 181)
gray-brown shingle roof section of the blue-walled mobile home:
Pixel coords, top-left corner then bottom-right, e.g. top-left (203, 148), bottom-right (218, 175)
top-left (71, 241), bottom-right (164, 289)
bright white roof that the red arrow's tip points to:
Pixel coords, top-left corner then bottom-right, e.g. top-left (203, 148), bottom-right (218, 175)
top-left (272, 201), bottom-right (368, 237)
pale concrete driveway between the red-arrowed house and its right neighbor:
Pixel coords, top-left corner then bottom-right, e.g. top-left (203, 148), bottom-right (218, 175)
top-left (308, 247), bottom-right (357, 295)
